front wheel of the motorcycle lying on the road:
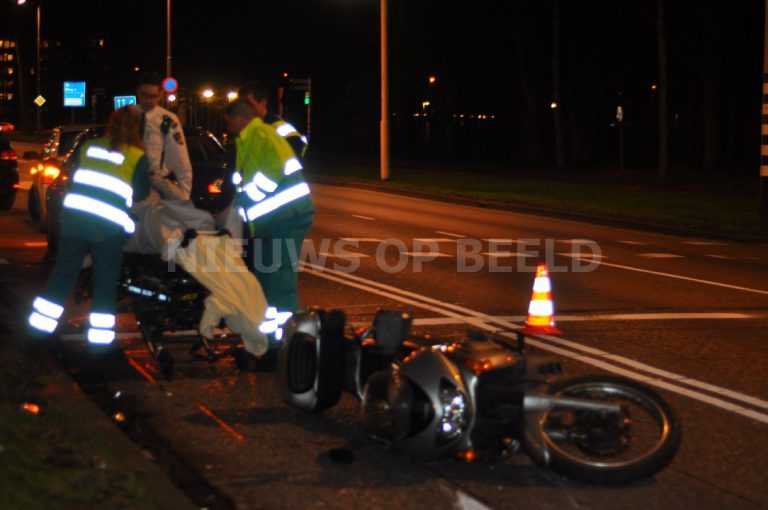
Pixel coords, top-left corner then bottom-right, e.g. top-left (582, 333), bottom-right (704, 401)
top-left (524, 375), bottom-right (682, 484)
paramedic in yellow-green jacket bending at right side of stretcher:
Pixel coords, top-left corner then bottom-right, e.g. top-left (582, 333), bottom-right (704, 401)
top-left (224, 99), bottom-right (315, 347)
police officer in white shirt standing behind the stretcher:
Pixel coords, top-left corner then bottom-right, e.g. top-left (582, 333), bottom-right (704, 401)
top-left (136, 74), bottom-right (192, 200)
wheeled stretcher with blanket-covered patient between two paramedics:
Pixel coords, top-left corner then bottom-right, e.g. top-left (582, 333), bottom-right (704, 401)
top-left (118, 201), bottom-right (268, 378)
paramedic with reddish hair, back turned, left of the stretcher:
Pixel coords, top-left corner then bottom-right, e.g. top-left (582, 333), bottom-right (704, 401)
top-left (28, 106), bottom-right (150, 344)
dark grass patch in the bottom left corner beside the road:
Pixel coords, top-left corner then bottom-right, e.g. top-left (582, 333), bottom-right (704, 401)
top-left (0, 336), bottom-right (190, 510)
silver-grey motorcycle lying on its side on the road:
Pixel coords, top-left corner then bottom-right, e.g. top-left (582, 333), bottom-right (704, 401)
top-left (278, 309), bottom-right (681, 484)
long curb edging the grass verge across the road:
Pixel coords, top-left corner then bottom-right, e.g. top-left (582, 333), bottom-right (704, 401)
top-left (307, 175), bottom-right (768, 243)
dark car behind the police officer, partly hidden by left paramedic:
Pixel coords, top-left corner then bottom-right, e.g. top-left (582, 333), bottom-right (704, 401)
top-left (45, 126), bottom-right (234, 253)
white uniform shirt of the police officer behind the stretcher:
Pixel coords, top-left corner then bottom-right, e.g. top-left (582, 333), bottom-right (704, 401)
top-left (144, 106), bottom-right (192, 199)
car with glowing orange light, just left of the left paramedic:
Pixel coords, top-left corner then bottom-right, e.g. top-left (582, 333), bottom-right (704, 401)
top-left (27, 124), bottom-right (97, 231)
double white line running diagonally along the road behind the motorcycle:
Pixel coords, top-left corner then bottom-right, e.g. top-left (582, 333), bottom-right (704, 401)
top-left (301, 262), bottom-right (768, 424)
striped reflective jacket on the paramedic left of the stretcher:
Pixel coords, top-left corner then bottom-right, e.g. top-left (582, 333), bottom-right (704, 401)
top-left (63, 137), bottom-right (144, 234)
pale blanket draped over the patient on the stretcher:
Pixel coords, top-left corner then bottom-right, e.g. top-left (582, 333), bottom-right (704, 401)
top-left (125, 200), bottom-right (268, 356)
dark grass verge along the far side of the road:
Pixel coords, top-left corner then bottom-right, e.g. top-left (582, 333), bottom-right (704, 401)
top-left (306, 159), bottom-right (761, 237)
